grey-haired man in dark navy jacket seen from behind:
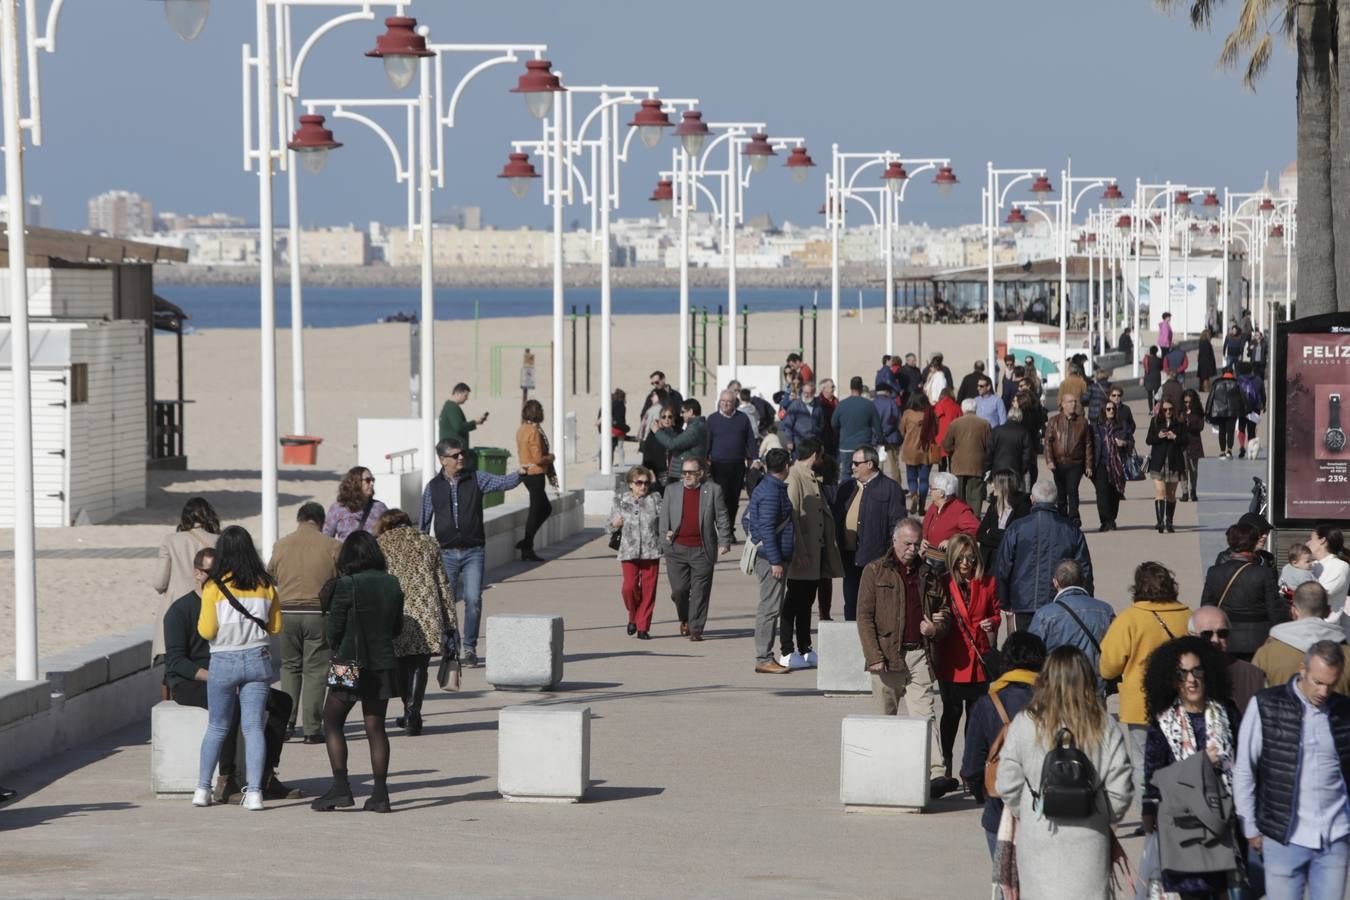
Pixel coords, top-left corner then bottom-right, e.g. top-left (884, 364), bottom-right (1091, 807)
top-left (994, 480), bottom-right (1092, 631)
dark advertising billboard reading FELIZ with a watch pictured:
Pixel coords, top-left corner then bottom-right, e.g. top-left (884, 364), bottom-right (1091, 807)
top-left (1270, 313), bottom-right (1350, 528)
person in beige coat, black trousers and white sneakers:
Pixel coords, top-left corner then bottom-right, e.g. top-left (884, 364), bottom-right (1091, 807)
top-left (778, 437), bottom-right (844, 669)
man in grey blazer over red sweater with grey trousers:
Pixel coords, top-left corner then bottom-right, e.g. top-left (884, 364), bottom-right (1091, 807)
top-left (657, 458), bottom-right (732, 641)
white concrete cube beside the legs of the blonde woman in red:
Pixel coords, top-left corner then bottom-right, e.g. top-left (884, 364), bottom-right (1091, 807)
top-left (840, 715), bottom-right (932, 812)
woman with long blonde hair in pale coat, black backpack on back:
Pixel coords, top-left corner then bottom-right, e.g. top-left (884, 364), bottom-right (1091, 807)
top-left (995, 646), bottom-right (1134, 900)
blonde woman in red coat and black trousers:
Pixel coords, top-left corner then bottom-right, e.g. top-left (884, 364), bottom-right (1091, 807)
top-left (933, 534), bottom-right (999, 793)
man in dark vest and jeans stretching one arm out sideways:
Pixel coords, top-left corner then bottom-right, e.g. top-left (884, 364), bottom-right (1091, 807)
top-left (419, 437), bottom-right (525, 665)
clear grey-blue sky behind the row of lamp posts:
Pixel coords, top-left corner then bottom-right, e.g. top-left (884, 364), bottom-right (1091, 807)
top-left (7, 0), bottom-right (1295, 228)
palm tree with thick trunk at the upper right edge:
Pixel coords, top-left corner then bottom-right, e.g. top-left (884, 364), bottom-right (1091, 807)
top-left (1154, 0), bottom-right (1350, 316)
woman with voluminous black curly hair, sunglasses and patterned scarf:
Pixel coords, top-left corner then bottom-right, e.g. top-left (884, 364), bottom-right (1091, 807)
top-left (1141, 636), bottom-right (1245, 900)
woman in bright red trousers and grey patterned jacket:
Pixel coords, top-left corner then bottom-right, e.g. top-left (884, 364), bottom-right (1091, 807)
top-left (609, 466), bottom-right (662, 641)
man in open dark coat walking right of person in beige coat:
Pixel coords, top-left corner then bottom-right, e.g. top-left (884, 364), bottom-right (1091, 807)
top-left (833, 445), bottom-right (905, 622)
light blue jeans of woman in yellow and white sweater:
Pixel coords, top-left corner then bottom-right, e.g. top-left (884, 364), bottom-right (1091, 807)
top-left (197, 646), bottom-right (275, 791)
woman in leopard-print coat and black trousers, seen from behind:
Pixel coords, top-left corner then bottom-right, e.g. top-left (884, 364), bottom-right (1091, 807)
top-left (375, 510), bottom-right (459, 737)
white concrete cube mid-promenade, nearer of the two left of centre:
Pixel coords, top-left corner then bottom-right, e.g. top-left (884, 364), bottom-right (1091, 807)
top-left (499, 701), bottom-right (590, 803)
